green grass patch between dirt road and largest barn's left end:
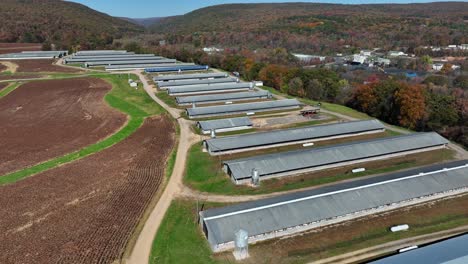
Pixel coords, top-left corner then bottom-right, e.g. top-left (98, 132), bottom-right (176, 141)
top-left (149, 200), bottom-right (222, 264)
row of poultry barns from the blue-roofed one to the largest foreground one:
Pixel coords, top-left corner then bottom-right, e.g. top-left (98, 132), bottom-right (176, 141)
top-left (153, 64), bottom-right (468, 252)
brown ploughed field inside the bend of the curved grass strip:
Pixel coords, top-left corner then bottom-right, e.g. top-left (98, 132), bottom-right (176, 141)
top-left (0, 78), bottom-right (127, 175)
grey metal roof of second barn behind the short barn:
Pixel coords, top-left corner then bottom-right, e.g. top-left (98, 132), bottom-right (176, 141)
top-left (176, 91), bottom-right (270, 104)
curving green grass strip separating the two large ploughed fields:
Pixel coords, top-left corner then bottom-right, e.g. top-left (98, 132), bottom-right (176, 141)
top-left (0, 74), bottom-right (164, 185)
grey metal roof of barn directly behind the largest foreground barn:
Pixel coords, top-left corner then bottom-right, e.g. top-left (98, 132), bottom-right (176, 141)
top-left (224, 132), bottom-right (448, 182)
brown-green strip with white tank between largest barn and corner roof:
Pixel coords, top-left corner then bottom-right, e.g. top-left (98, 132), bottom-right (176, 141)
top-left (218, 195), bottom-right (468, 263)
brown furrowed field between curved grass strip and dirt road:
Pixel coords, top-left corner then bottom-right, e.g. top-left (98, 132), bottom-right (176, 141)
top-left (0, 117), bottom-right (175, 264)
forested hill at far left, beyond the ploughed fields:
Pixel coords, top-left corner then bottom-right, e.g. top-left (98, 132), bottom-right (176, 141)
top-left (0, 0), bottom-right (143, 48)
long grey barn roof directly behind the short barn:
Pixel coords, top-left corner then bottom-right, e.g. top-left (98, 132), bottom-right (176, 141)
top-left (187, 99), bottom-right (301, 117)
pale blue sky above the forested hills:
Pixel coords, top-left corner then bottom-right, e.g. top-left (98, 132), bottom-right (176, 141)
top-left (70, 0), bottom-right (462, 18)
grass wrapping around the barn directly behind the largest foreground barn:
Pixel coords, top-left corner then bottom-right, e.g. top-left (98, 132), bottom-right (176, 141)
top-left (184, 139), bottom-right (454, 195)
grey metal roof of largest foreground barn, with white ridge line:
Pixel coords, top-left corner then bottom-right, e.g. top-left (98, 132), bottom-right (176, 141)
top-left (200, 160), bottom-right (468, 246)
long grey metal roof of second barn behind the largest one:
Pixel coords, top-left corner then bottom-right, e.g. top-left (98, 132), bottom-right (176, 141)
top-left (205, 120), bottom-right (385, 152)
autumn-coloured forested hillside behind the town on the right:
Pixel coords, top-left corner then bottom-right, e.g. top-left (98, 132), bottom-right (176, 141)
top-left (151, 2), bottom-right (468, 53)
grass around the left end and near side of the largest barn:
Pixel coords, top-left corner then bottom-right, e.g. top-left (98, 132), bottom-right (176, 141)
top-left (150, 195), bottom-right (468, 264)
